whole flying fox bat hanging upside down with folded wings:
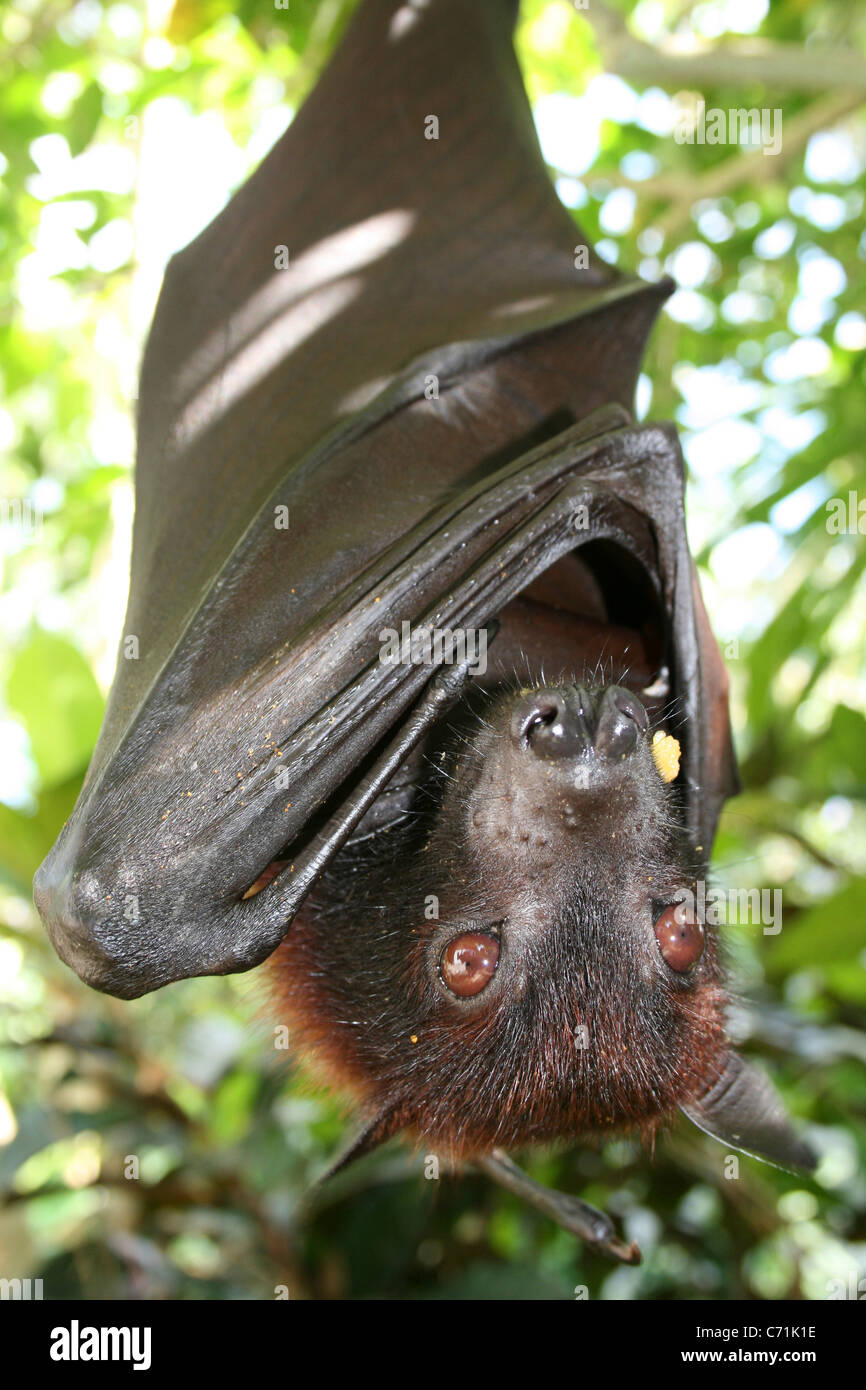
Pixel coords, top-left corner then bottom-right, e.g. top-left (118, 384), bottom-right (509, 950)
top-left (36, 0), bottom-right (809, 1258)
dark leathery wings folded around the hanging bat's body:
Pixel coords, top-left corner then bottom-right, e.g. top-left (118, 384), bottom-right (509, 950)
top-left (36, 0), bottom-right (734, 997)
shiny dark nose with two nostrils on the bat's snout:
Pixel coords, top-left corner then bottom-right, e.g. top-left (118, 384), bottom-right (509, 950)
top-left (510, 685), bottom-right (649, 762)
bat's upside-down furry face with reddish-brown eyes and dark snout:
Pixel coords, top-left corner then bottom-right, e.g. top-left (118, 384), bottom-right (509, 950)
top-left (269, 592), bottom-right (724, 1155)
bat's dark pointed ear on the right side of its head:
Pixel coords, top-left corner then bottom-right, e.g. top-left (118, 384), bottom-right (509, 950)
top-left (681, 1052), bottom-right (815, 1170)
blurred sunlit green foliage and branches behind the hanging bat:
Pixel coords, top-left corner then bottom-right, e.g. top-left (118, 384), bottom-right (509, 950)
top-left (0, 0), bottom-right (866, 1300)
